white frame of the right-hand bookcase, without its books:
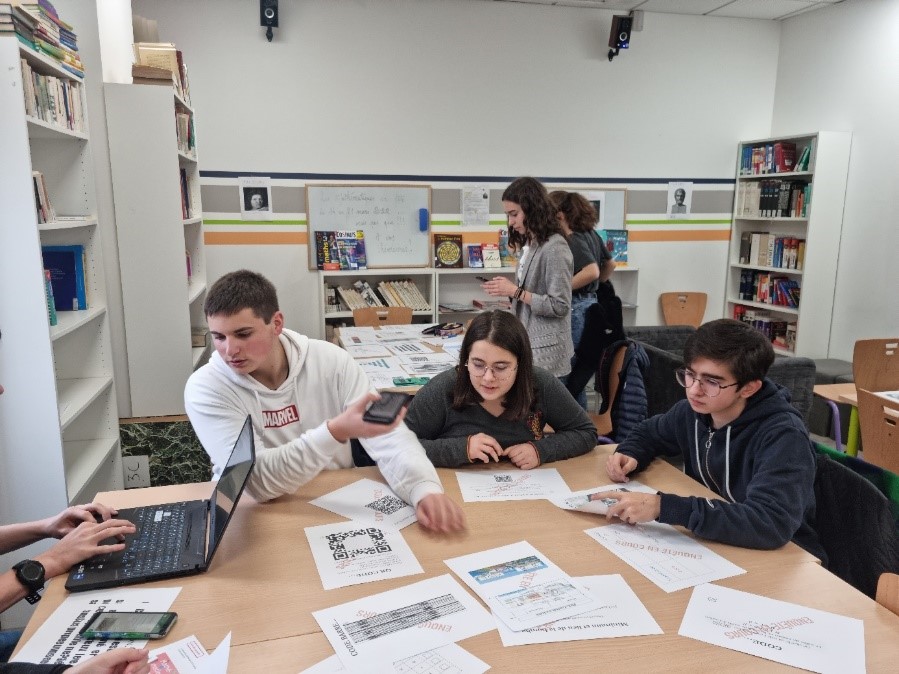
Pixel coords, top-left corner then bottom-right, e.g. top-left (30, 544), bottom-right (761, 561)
top-left (724, 132), bottom-right (851, 358)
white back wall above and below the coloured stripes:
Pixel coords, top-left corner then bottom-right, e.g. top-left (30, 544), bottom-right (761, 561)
top-left (132, 0), bottom-right (780, 334)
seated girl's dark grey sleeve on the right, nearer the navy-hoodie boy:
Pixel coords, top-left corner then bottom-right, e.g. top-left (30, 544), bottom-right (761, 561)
top-left (534, 372), bottom-right (596, 463)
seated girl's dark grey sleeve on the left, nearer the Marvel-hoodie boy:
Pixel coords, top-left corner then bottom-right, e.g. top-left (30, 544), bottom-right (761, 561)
top-left (406, 371), bottom-right (469, 468)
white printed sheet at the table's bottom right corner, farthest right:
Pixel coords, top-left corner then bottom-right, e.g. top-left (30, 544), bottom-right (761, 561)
top-left (678, 584), bottom-right (865, 674)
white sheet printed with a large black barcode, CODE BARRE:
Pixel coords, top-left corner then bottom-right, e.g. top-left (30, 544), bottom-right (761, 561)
top-left (312, 574), bottom-right (496, 673)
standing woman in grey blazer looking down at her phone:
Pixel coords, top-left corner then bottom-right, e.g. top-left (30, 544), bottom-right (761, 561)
top-left (481, 178), bottom-right (574, 377)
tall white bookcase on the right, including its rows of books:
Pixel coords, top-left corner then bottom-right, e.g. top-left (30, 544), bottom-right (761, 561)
top-left (724, 132), bottom-right (851, 358)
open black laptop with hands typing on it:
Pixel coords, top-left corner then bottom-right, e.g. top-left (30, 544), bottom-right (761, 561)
top-left (66, 417), bottom-right (256, 592)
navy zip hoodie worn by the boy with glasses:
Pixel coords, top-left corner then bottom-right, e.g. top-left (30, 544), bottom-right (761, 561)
top-left (617, 379), bottom-right (827, 563)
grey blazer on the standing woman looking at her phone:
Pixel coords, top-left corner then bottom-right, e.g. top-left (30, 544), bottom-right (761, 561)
top-left (512, 234), bottom-right (574, 377)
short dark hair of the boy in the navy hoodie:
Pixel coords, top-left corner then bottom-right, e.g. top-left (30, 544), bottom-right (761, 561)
top-left (684, 318), bottom-right (774, 386)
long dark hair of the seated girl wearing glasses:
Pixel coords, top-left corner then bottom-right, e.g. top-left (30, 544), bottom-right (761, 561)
top-left (453, 311), bottom-right (536, 419)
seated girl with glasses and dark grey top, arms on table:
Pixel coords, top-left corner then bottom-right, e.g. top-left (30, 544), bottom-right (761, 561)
top-left (406, 311), bottom-right (596, 470)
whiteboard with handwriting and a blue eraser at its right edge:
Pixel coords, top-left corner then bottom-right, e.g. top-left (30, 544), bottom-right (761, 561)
top-left (306, 185), bottom-right (431, 269)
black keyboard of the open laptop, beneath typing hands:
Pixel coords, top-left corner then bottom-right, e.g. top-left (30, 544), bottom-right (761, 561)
top-left (89, 503), bottom-right (188, 578)
